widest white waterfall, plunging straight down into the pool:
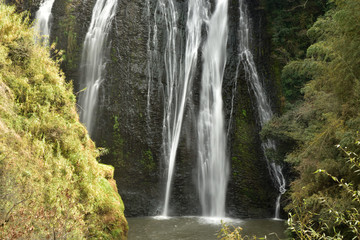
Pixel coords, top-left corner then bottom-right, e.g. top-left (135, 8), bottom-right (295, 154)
top-left (198, 0), bottom-right (229, 217)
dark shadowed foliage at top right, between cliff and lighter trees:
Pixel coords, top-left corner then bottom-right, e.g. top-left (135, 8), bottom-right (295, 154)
top-left (262, 0), bottom-right (327, 107)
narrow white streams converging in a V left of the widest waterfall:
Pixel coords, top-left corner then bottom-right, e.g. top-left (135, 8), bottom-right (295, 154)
top-left (154, 0), bottom-right (207, 216)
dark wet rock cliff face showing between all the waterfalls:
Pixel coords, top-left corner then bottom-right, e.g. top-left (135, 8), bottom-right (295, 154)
top-left (11, 0), bottom-right (282, 217)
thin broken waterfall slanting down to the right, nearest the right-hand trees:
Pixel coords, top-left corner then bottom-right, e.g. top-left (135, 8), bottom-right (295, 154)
top-left (239, 0), bottom-right (286, 218)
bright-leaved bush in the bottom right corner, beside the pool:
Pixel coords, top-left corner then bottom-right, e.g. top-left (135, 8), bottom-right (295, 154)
top-left (288, 143), bottom-right (360, 240)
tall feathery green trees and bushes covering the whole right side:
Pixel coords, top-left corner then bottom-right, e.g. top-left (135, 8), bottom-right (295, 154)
top-left (262, 0), bottom-right (360, 239)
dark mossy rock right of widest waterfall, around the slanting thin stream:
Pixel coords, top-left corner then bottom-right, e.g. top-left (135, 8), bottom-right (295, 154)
top-left (223, 0), bottom-right (276, 217)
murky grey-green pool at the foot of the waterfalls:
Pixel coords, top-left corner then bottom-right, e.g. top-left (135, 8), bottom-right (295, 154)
top-left (128, 217), bottom-right (285, 240)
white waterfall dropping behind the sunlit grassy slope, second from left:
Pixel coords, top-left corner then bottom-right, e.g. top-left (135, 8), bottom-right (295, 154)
top-left (79, 0), bottom-right (118, 135)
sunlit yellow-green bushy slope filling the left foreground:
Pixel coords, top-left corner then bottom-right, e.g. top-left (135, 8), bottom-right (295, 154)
top-left (0, 1), bottom-right (128, 239)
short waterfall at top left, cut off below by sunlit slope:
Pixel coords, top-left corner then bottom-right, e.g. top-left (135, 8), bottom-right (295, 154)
top-left (35, 0), bottom-right (55, 45)
